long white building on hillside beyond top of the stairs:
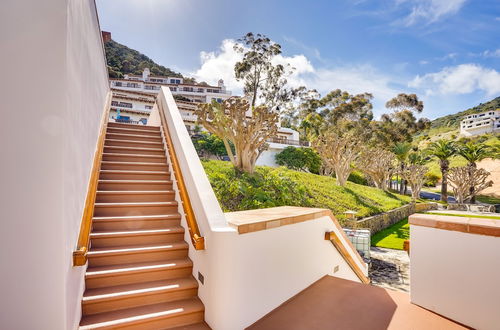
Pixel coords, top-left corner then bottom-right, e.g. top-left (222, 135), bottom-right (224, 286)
top-left (109, 68), bottom-right (231, 103)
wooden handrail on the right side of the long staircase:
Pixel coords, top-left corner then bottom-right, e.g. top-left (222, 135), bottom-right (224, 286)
top-left (158, 104), bottom-right (205, 250)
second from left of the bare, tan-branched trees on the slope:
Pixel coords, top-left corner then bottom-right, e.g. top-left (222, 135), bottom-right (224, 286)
top-left (312, 130), bottom-right (361, 187)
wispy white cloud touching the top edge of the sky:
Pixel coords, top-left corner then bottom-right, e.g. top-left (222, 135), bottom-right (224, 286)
top-left (396, 0), bottom-right (467, 26)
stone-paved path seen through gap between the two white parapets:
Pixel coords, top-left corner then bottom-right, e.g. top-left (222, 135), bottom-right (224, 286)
top-left (369, 247), bottom-right (410, 293)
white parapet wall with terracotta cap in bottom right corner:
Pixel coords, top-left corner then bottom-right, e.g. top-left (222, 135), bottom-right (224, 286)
top-left (410, 214), bottom-right (500, 330)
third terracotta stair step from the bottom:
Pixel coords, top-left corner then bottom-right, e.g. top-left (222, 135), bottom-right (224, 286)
top-left (85, 258), bottom-right (193, 289)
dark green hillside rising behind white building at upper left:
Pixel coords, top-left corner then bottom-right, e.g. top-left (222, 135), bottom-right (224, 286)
top-left (104, 40), bottom-right (182, 78)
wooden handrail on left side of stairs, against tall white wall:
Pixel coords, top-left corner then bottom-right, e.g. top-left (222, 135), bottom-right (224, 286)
top-left (73, 94), bottom-right (111, 266)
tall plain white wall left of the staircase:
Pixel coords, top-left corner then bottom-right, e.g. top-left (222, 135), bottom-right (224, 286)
top-left (0, 0), bottom-right (109, 330)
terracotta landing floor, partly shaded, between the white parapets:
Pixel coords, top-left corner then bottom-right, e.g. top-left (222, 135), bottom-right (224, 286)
top-left (247, 276), bottom-right (466, 330)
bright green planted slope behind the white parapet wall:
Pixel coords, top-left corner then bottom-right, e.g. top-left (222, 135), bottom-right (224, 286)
top-left (203, 160), bottom-right (410, 219)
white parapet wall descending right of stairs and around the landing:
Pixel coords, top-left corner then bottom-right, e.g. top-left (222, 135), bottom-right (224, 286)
top-left (148, 88), bottom-right (367, 330)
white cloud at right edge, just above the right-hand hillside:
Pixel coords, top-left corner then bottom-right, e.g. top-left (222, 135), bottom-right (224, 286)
top-left (408, 64), bottom-right (500, 96)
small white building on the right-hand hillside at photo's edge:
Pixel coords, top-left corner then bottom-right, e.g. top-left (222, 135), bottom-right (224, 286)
top-left (460, 109), bottom-right (500, 136)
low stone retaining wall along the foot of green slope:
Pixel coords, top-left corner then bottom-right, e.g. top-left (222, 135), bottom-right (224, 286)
top-left (356, 203), bottom-right (437, 235)
